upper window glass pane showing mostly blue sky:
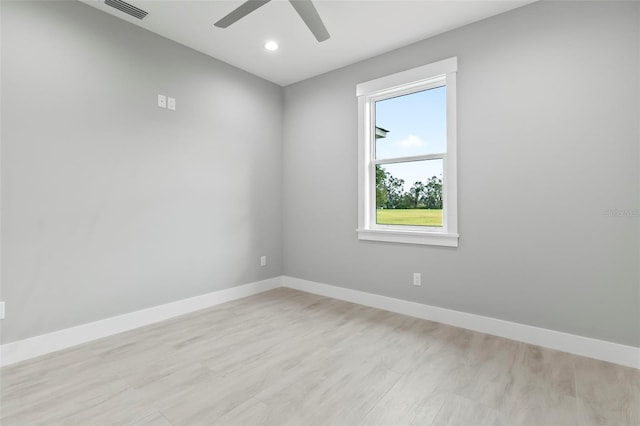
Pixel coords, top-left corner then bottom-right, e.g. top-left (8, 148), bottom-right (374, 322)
top-left (375, 86), bottom-right (447, 159)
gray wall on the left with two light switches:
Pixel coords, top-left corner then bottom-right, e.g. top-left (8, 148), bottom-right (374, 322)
top-left (1, 1), bottom-right (283, 343)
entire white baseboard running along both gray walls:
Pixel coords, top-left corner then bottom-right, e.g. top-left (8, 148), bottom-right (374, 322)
top-left (0, 276), bottom-right (640, 368)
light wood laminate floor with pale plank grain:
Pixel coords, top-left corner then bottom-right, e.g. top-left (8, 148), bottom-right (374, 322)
top-left (0, 288), bottom-right (640, 426)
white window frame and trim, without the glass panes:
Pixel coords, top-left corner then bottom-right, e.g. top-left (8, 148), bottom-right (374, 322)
top-left (356, 57), bottom-right (459, 247)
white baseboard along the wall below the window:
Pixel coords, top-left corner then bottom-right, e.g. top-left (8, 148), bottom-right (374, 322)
top-left (282, 276), bottom-right (640, 368)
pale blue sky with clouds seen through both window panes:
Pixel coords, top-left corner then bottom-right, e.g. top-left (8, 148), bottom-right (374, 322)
top-left (376, 86), bottom-right (447, 190)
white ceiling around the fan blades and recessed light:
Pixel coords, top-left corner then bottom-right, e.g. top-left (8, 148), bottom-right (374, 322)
top-left (80, 0), bottom-right (533, 86)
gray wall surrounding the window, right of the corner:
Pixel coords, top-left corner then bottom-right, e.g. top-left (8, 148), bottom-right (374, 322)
top-left (283, 2), bottom-right (640, 346)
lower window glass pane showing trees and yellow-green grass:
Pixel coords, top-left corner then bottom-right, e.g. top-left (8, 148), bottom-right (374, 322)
top-left (376, 159), bottom-right (443, 227)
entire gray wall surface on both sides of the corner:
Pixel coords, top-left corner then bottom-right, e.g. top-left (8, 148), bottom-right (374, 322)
top-left (0, 1), bottom-right (640, 346)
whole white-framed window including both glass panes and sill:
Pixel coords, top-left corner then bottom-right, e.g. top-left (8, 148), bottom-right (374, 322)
top-left (356, 58), bottom-right (458, 247)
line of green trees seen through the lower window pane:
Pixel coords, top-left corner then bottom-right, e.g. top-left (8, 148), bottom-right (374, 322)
top-left (376, 165), bottom-right (442, 209)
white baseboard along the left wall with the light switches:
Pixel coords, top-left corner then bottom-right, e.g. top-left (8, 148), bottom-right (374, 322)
top-left (0, 277), bottom-right (282, 366)
